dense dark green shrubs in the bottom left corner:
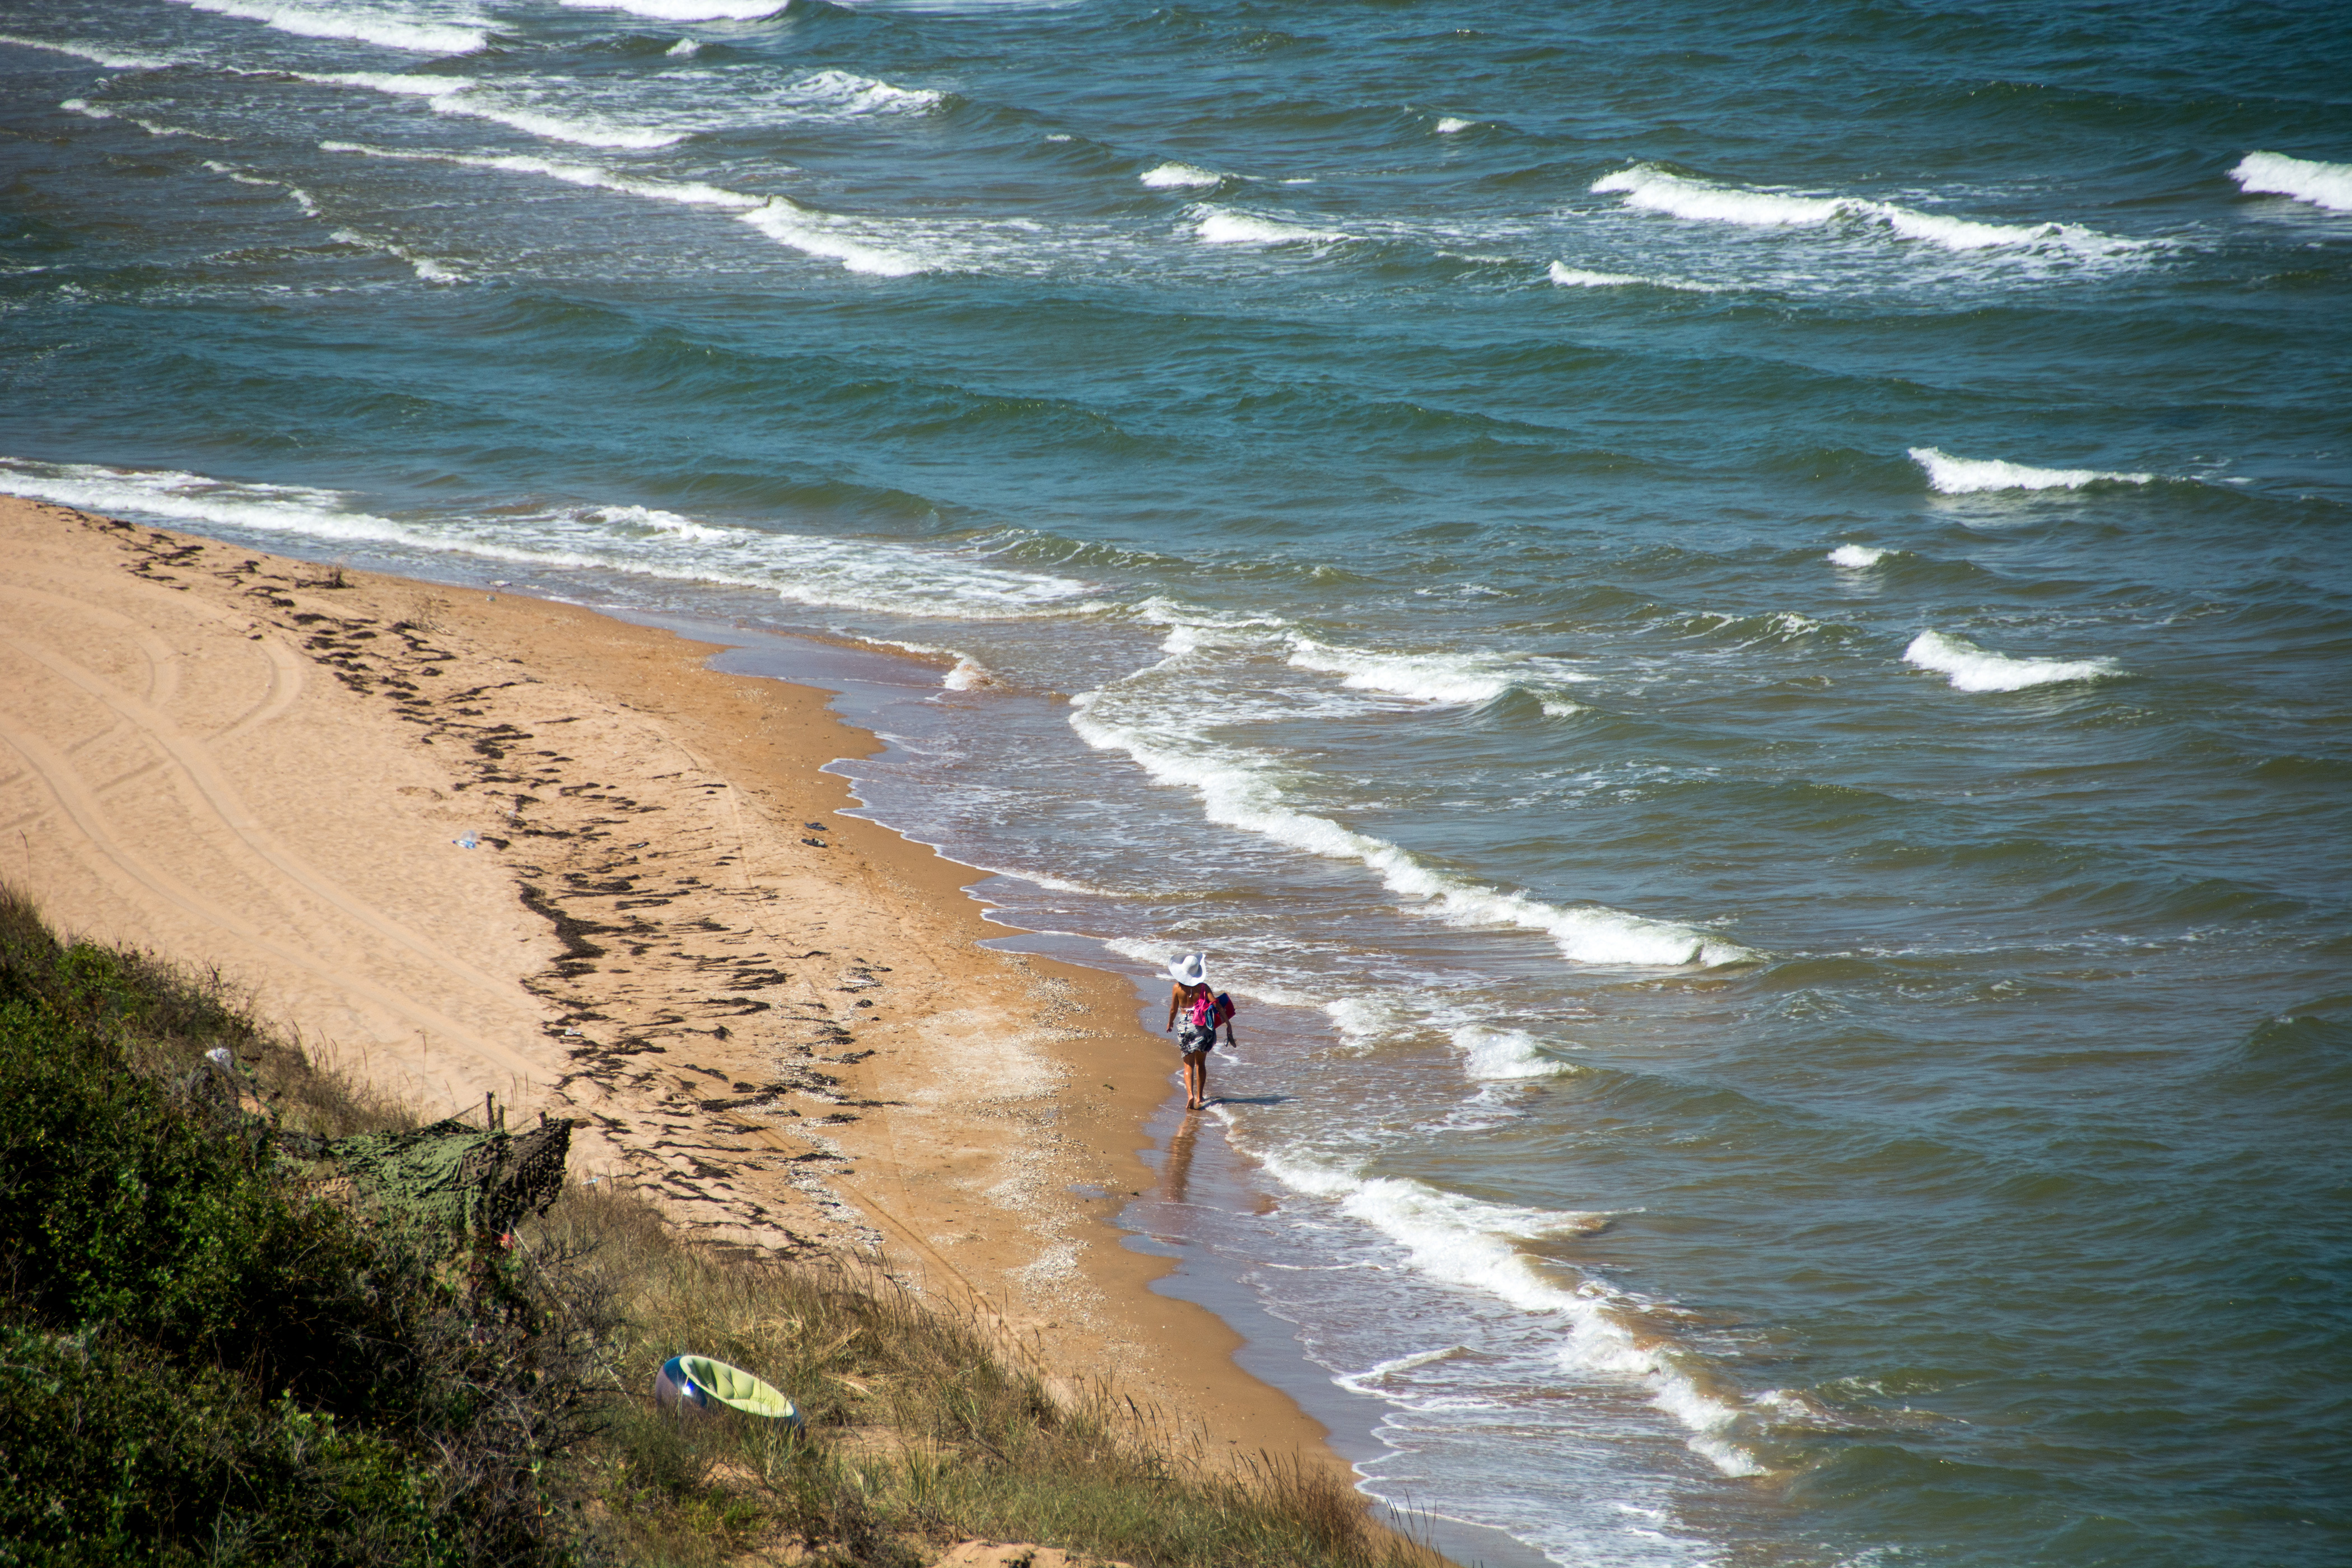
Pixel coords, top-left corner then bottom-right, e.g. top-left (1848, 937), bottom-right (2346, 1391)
top-left (0, 891), bottom-right (588, 1566)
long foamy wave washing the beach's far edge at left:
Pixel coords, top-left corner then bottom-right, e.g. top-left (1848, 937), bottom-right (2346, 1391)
top-left (0, 459), bottom-right (1101, 620)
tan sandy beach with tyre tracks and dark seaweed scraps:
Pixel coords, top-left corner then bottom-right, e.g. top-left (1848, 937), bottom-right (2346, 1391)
top-left (0, 496), bottom-right (1336, 1462)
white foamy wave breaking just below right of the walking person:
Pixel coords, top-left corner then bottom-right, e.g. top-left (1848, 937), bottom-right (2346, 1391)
top-left (1263, 1154), bottom-right (1764, 1476)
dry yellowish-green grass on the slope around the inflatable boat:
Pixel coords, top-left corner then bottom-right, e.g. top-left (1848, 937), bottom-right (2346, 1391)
top-left (539, 1189), bottom-right (1439, 1568)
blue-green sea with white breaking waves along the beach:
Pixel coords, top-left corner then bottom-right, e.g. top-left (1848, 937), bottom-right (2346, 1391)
top-left (0, 0), bottom-right (2352, 1568)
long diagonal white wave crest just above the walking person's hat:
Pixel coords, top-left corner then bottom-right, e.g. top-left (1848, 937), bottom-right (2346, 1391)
top-left (1070, 691), bottom-right (1752, 969)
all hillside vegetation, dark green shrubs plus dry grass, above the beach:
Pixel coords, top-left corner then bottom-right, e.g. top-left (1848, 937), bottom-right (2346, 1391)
top-left (0, 889), bottom-right (1437, 1568)
